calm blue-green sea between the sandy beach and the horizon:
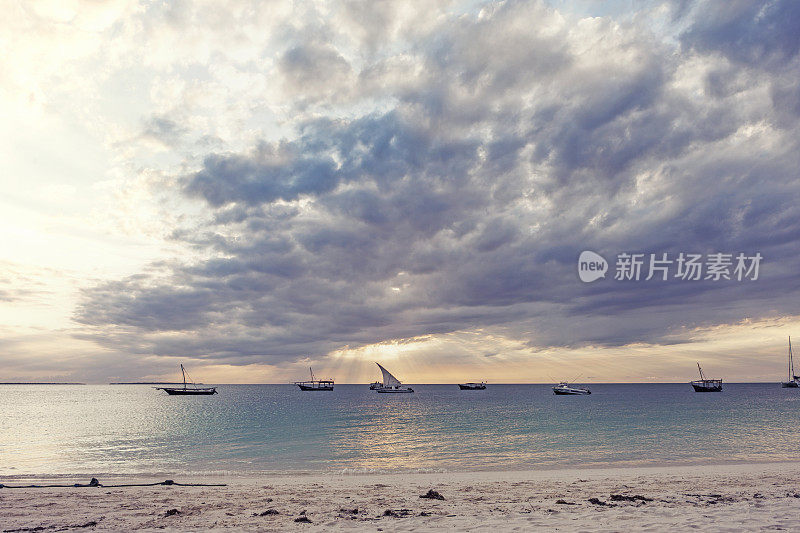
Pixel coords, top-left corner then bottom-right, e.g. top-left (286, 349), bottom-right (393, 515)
top-left (0, 384), bottom-right (800, 479)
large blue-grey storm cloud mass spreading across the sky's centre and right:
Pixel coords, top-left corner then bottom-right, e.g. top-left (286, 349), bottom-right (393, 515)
top-left (77, 2), bottom-right (800, 363)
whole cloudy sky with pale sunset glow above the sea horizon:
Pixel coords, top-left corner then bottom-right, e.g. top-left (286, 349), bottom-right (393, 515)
top-left (0, 0), bottom-right (800, 383)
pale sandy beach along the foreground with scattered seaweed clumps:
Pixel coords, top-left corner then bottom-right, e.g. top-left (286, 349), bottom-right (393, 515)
top-left (0, 463), bottom-right (800, 531)
